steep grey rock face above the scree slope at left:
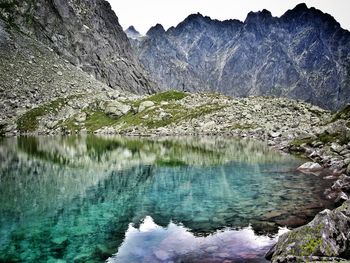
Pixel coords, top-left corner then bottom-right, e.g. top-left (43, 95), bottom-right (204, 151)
top-left (0, 0), bottom-right (153, 93)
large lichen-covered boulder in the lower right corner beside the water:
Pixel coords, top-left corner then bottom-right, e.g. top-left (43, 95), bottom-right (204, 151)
top-left (268, 201), bottom-right (350, 263)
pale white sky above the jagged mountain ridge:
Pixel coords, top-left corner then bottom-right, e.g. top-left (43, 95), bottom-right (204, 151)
top-left (108, 0), bottom-right (350, 34)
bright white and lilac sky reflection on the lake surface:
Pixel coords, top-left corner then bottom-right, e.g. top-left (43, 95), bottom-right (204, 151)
top-left (107, 216), bottom-right (288, 263)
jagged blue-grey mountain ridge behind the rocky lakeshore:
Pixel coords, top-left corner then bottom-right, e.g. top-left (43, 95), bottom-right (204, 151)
top-left (133, 4), bottom-right (350, 110)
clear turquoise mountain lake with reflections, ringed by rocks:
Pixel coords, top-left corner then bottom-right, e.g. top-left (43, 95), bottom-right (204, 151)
top-left (0, 136), bottom-right (331, 262)
